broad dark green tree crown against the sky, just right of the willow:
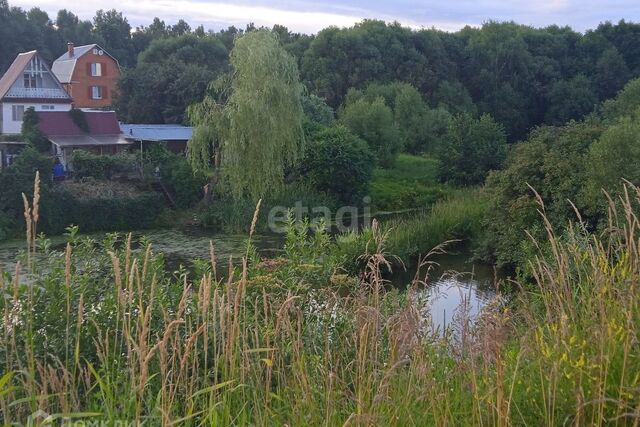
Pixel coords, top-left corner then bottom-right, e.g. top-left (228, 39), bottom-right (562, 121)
top-left (302, 20), bottom-right (454, 107)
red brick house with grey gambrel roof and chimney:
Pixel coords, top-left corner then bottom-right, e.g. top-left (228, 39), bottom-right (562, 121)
top-left (51, 43), bottom-right (120, 108)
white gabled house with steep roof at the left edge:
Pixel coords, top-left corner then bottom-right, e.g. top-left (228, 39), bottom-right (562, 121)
top-left (0, 50), bottom-right (72, 134)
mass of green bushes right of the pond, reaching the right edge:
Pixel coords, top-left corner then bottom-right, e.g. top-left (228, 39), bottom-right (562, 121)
top-left (481, 81), bottom-right (640, 271)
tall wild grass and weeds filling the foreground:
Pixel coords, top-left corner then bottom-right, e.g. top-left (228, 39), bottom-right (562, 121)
top-left (0, 176), bottom-right (640, 426)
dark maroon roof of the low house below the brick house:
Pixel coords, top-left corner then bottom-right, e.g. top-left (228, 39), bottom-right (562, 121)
top-left (37, 111), bottom-right (120, 136)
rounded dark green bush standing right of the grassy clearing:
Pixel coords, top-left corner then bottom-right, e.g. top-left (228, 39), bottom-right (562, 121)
top-left (436, 114), bottom-right (507, 185)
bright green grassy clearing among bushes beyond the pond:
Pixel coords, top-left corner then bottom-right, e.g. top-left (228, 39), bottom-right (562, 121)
top-left (369, 154), bottom-right (452, 211)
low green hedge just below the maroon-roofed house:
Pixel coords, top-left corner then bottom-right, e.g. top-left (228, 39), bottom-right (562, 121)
top-left (71, 150), bottom-right (137, 179)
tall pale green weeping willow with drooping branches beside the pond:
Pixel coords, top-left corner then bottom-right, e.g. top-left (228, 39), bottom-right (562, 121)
top-left (189, 30), bottom-right (304, 198)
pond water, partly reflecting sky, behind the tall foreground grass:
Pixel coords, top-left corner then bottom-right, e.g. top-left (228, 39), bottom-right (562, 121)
top-left (0, 228), bottom-right (500, 330)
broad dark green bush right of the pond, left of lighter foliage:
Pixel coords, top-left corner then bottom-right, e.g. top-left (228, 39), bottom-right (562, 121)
top-left (484, 120), bottom-right (602, 267)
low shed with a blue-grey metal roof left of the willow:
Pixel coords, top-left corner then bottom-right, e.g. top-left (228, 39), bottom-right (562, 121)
top-left (120, 123), bottom-right (193, 154)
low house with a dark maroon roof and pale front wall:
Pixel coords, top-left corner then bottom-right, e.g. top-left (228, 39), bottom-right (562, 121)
top-left (38, 111), bottom-right (132, 170)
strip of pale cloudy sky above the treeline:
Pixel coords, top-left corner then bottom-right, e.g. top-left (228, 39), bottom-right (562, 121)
top-left (9, 0), bottom-right (640, 33)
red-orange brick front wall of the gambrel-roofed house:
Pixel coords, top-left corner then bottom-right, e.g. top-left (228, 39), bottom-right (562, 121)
top-left (65, 50), bottom-right (120, 108)
